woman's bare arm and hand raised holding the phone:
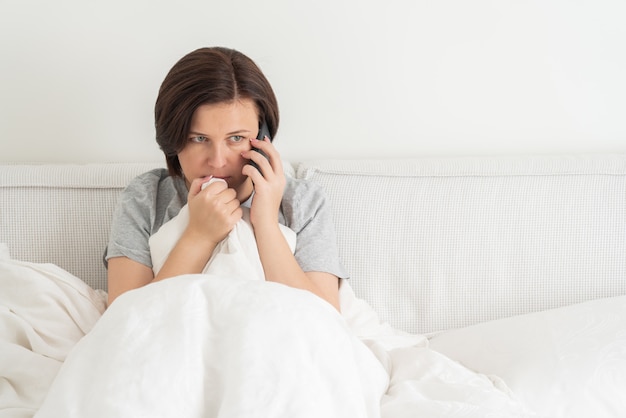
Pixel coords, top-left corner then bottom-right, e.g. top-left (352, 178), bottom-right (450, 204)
top-left (244, 139), bottom-right (340, 310)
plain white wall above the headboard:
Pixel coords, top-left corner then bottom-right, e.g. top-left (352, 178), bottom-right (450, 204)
top-left (0, 0), bottom-right (626, 163)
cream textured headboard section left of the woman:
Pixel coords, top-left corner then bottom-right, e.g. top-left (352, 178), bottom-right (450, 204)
top-left (0, 163), bottom-right (158, 289)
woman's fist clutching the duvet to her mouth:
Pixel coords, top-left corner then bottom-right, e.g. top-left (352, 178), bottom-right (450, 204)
top-left (186, 178), bottom-right (243, 245)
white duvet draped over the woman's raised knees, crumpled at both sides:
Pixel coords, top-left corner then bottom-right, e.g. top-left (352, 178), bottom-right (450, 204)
top-left (0, 195), bottom-right (535, 418)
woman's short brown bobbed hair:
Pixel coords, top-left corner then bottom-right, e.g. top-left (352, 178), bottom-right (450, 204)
top-left (154, 47), bottom-right (279, 176)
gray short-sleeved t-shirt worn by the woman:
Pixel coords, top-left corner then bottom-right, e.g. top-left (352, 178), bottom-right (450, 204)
top-left (105, 168), bottom-right (348, 278)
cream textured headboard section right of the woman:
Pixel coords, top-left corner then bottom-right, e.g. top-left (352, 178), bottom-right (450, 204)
top-left (297, 155), bottom-right (626, 333)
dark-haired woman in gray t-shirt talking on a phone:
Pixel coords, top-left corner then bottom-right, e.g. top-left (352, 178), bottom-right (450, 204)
top-left (106, 48), bottom-right (346, 310)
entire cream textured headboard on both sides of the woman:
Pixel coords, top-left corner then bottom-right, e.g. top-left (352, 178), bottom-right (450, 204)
top-left (0, 155), bottom-right (626, 333)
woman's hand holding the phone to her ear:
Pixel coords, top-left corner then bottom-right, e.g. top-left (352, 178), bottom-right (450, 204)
top-left (242, 137), bottom-right (286, 229)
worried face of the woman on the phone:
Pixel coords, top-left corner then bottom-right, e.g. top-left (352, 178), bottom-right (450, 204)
top-left (178, 99), bottom-right (259, 201)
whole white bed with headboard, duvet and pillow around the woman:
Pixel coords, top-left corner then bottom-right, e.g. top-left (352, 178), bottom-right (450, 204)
top-left (0, 155), bottom-right (626, 418)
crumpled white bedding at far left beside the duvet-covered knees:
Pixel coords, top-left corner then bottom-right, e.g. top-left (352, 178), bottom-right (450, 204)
top-left (0, 243), bottom-right (106, 418)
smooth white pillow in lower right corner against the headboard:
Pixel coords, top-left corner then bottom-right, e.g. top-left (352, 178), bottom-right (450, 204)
top-left (430, 296), bottom-right (626, 418)
